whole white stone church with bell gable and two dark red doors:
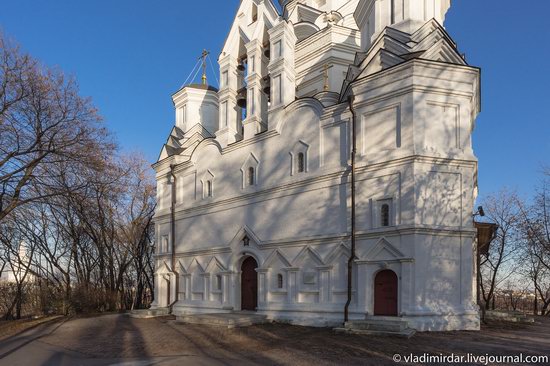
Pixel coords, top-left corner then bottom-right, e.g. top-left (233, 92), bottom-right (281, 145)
top-left (153, 0), bottom-right (480, 331)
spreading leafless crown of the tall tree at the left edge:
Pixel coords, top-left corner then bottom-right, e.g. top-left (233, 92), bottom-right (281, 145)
top-left (0, 34), bottom-right (110, 221)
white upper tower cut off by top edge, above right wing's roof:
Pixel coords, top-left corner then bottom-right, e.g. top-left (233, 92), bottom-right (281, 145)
top-left (354, 0), bottom-right (451, 51)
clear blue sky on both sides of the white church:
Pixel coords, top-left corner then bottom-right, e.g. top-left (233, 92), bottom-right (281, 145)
top-left (0, 0), bottom-right (550, 200)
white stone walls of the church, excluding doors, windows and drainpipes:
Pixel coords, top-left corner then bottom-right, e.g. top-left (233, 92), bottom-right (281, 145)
top-left (155, 0), bottom-right (479, 330)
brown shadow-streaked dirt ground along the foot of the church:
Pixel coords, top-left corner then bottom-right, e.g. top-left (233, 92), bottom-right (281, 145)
top-left (35, 315), bottom-right (550, 366)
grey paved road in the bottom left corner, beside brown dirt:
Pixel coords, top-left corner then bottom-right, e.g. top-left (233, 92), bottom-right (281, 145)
top-left (0, 320), bottom-right (256, 366)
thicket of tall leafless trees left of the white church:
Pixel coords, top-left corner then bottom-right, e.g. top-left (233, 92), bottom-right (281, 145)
top-left (0, 35), bottom-right (156, 318)
